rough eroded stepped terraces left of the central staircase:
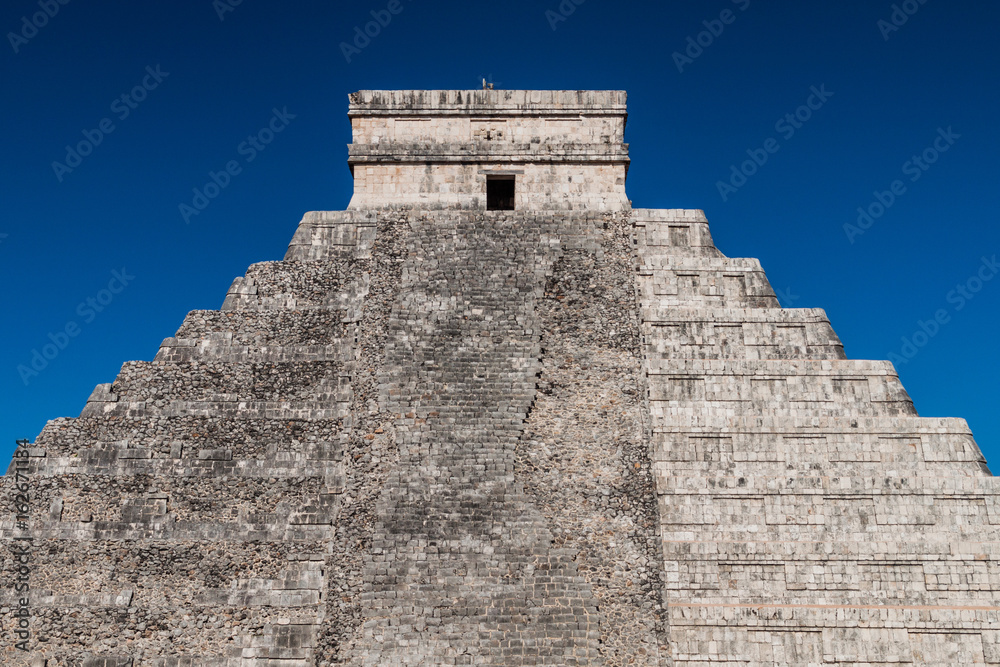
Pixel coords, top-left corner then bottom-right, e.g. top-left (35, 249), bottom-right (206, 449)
top-left (0, 210), bottom-right (401, 667)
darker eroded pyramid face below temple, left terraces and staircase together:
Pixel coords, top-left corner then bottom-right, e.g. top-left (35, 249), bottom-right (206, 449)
top-left (0, 211), bottom-right (669, 667)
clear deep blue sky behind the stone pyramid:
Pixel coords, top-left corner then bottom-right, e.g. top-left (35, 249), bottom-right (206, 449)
top-left (0, 0), bottom-right (1000, 469)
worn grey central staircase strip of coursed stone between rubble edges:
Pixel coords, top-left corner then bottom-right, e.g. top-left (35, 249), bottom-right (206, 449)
top-left (344, 215), bottom-right (599, 665)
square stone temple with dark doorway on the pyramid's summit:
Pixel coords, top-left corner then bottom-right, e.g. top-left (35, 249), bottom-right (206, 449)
top-left (349, 90), bottom-right (629, 211)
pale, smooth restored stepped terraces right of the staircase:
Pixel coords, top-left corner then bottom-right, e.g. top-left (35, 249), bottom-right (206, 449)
top-left (636, 211), bottom-right (1000, 667)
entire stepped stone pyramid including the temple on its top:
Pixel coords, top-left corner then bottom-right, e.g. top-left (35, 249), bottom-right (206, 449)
top-left (0, 90), bottom-right (1000, 667)
